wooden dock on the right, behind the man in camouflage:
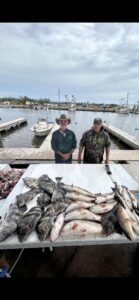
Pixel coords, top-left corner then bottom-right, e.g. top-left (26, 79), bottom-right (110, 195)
top-left (103, 123), bottom-right (139, 150)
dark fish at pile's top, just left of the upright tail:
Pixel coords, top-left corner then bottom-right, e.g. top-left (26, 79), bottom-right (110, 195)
top-left (38, 175), bottom-right (56, 195)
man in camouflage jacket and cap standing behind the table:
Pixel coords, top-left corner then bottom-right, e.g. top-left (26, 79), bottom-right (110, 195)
top-left (78, 118), bottom-right (111, 164)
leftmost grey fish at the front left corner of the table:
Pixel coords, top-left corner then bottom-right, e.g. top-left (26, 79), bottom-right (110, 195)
top-left (0, 204), bottom-right (22, 242)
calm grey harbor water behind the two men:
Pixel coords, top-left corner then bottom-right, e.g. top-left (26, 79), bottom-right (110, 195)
top-left (0, 108), bottom-right (139, 149)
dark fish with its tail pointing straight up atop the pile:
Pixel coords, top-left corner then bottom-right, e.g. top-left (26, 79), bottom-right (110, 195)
top-left (51, 177), bottom-right (65, 203)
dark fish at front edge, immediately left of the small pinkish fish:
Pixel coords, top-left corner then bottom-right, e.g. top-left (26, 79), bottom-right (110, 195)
top-left (36, 213), bottom-right (54, 242)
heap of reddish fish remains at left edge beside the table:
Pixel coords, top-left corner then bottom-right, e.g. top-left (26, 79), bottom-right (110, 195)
top-left (0, 169), bottom-right (25, 199)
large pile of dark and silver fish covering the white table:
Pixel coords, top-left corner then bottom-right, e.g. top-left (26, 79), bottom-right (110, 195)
top-left (0, 174), bottom-right (139, 242)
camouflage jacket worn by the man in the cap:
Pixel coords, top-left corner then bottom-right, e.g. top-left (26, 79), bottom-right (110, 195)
top-left (80, 128), bottom-right (111, 163)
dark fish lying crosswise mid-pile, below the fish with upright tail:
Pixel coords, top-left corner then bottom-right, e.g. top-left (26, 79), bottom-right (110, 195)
top-left (45, 201), bottom-right (69, 217)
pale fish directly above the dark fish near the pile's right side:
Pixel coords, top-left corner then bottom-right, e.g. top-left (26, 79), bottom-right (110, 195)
top-left (90, 201), bottom-right (117, 214)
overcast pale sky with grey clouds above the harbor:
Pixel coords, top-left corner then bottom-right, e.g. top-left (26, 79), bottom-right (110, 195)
top-left (0, 23), bottom-right (139, 104)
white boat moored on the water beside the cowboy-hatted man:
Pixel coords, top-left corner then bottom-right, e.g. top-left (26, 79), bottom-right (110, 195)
top-left (30, 119), bottom-right (54, 136)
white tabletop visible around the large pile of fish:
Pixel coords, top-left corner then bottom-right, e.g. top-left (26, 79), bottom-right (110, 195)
top-left (0, 164), bottom-right (139, 249)
